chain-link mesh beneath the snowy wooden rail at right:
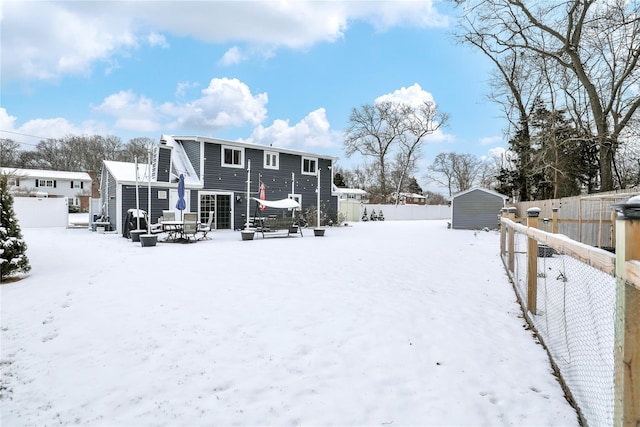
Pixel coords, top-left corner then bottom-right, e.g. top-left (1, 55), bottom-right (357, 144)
top-left (504, 228), bottom-right (616, 426)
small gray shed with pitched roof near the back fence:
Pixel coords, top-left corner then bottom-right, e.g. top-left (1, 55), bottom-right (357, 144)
top-left (451, 190), bottom-right (504, 230)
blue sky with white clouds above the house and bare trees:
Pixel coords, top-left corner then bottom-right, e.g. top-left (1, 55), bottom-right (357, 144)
top-left (0, 0), bottom-right (505, 186)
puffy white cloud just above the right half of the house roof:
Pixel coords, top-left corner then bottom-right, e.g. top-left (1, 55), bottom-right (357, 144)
top-left (246, 108), bottom-right (342, 151)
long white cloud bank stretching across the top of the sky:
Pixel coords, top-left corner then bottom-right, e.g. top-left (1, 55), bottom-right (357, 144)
top-left (0, 0), bottom-right (447, 81)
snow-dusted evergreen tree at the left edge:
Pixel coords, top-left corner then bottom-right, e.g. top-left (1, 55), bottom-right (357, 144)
top-left (0, 175), bottom-right (31, 282)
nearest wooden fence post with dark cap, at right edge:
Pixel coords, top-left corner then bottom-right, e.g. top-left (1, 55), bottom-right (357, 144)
top-left (613, 196), bottom-right (640, 427)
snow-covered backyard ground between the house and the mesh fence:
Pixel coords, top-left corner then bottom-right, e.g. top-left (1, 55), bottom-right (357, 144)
top-left (0, 221), bottom-right (578, 426)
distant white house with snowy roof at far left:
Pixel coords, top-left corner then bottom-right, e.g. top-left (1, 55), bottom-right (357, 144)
top-left (0, 168), bottom-right (92, 211)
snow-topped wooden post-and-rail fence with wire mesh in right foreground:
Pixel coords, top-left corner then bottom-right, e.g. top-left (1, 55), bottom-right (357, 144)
top-left (500, 204), bottom-right (640, 427)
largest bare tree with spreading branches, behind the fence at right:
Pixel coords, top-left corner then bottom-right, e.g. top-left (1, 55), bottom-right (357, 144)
top-left (456, 0), bottom-right (640, 191)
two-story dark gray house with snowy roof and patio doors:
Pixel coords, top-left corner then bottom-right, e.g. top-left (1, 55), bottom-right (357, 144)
top-left (100, 135), bottom-right (338, 232)
